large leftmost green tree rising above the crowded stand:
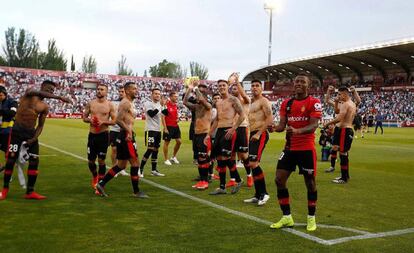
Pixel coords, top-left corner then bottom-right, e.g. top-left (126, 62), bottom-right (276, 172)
top-left (3, 27), bottom-right (40, 68)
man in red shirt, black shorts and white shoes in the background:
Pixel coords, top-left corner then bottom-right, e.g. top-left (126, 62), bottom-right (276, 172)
top-left (161, 91), bottom-right (181, 166)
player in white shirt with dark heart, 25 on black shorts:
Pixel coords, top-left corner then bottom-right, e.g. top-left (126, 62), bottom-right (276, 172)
top-left (139, 87), bottom-right (165, 177)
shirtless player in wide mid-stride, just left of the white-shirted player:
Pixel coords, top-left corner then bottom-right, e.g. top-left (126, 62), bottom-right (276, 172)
top-left (96, 82), bottom-right (148, 198)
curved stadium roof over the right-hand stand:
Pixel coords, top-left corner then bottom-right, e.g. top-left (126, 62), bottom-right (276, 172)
top-left (243, 37), bottom-right (414, 82)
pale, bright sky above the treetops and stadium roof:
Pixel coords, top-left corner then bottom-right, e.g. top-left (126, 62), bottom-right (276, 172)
top-left (0, 0), bottom-right (414, 79)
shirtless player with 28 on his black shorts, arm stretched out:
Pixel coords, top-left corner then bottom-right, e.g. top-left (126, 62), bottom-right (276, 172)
top-left (0, 81), bottom-right (71, 200)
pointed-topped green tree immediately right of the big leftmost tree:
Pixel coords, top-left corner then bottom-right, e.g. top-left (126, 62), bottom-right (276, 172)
top-left (40, 39), bottom-right (67, 71)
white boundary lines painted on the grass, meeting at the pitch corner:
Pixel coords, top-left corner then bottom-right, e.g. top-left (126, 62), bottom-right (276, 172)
top-left (40, 143), bottom-right (414, 245)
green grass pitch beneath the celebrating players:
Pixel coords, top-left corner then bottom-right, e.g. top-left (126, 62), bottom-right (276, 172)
top-left (0, 119), bottom-right (414, 253)
